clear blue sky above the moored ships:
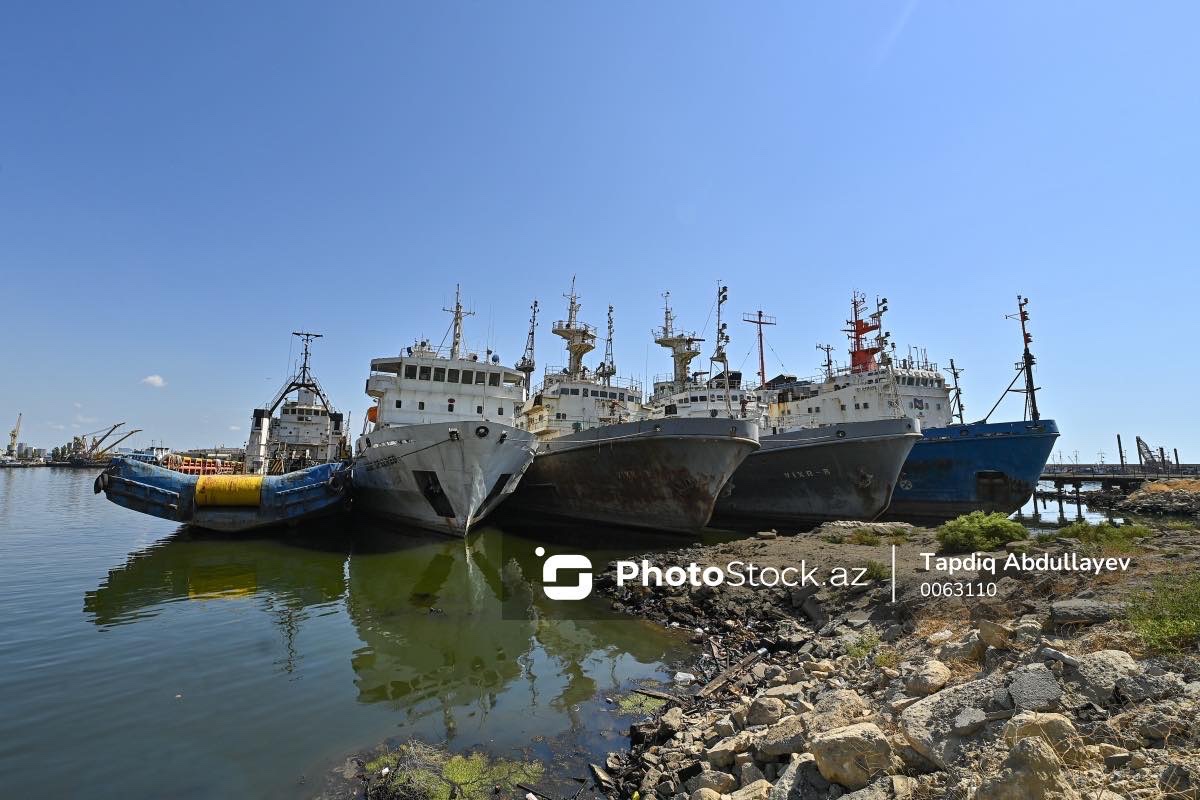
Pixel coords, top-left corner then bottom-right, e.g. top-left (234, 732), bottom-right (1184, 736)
top-left (0, 0), bottom-right (1200, 462)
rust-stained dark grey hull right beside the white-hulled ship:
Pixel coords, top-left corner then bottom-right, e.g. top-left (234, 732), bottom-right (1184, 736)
top-left (503, 417), bottom-right (758, 534)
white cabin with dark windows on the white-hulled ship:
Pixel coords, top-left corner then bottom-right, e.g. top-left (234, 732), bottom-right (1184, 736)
top-left (366, 341), bottom-right (524, 428)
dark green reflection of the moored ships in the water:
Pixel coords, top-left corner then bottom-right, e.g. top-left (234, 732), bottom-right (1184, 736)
top-left (84, 519), bottom-right (686, 753)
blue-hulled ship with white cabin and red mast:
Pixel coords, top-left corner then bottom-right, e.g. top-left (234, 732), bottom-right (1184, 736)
top-left (767, 293), bottom-right (1058, 524)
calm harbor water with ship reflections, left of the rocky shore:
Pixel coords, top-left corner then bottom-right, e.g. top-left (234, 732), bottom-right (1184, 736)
top-left (0, 468), bottom-right (686, 798)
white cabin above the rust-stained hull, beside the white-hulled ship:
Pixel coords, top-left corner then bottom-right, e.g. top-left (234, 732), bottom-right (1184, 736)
top-left (517, 367), bottom-right (646, 441)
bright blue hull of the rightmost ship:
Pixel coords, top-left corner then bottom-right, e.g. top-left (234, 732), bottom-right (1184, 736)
top-left (884, 420), bottom-right (1058, 524)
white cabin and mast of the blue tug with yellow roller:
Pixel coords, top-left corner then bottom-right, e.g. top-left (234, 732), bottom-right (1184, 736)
top-left (244, 331), bottom-right (349, 475)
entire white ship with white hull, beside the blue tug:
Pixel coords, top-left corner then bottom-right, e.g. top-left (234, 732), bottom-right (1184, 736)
top-left (354, 290), bottom-right (535, 535)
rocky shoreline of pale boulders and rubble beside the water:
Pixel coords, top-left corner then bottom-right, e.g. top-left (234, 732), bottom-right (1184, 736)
top-left (593, 523), bottom-right (1200, 800)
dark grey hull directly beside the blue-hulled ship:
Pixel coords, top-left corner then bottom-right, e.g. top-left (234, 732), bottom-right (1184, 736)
top-left (713, 419), bottom-right (920, 529)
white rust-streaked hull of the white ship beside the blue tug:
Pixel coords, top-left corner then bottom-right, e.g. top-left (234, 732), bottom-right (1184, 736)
top-left (353, 421), bottom-right (535, 536)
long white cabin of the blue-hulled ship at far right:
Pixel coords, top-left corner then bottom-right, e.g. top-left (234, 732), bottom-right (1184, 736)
top-left (767, 359), bottom-right (952, 433)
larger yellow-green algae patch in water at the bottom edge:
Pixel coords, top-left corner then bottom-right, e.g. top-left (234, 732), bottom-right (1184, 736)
top-left (366, 740), bottom-right (542, 800)
